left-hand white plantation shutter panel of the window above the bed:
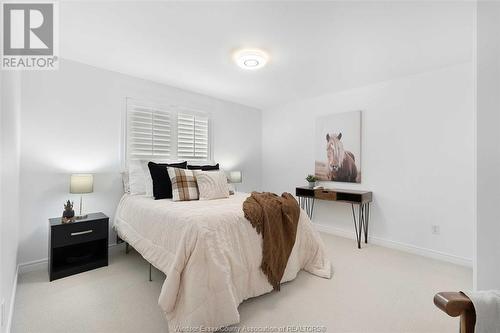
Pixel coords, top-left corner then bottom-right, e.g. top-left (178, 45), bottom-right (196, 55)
top-left (127, 101), bottom-right (171, 160)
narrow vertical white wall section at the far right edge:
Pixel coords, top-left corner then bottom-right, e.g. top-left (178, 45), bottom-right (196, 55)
top-left (474, 1), bottom-right (500, 290)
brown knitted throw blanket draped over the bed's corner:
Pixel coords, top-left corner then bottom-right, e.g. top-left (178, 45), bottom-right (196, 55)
top-left (243, 192), bottom-right (300, 290)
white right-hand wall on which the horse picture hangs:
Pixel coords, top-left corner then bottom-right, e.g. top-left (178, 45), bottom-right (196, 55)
top-left (262, 63), bottom-right (474, 264)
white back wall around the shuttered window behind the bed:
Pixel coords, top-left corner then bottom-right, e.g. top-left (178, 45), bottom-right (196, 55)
top-left (19, 61), bottom-right (261, 263)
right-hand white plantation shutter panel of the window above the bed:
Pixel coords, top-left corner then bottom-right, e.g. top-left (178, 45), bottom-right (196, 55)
top-left (177, 112), bottom-right (210, 161)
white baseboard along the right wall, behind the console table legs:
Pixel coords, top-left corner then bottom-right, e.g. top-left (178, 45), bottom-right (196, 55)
top-left (313, 223), bottom-right (472, 267)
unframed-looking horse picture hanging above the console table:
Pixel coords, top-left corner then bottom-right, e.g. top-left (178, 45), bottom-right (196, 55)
top-left (314, 111), bottom-right (361, 183)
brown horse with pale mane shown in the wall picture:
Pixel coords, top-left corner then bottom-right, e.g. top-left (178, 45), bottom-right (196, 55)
top-left (326, 133), bottom-right (358, 183)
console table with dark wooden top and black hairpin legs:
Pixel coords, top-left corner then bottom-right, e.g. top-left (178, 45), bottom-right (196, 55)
top-left (295, 187), bottom-right (372, 249)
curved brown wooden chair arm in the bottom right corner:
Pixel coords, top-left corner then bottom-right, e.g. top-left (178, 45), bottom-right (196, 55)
top-left (434, 292), bottom-right (476, 333)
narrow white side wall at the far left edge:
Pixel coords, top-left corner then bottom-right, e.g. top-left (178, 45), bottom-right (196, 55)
top-left (0, 72), bottom-right (21, 332)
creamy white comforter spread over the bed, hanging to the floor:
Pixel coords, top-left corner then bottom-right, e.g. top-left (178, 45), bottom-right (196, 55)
top-left (114, 193), bottom-right (331, 332)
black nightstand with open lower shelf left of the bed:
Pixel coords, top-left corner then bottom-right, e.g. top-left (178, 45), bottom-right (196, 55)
top-left (49, 213), bottom-right (109, 281)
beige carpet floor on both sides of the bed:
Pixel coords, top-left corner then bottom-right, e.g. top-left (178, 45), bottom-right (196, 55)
top-left (12, 234), bottom-right (472, 333)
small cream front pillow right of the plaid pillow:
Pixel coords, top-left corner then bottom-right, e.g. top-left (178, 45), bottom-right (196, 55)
top-left (194, 171), bottom-right (229, 200)
